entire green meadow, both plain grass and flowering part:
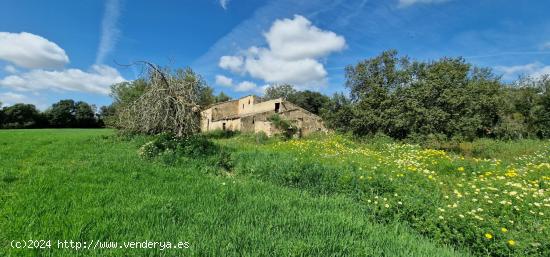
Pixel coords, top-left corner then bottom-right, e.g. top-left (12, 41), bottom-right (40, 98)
top-left (0, 129), bottom-right (550, 256)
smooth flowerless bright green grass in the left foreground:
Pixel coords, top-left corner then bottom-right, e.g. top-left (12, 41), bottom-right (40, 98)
top-left (0, 130), bottom-right (470, 256)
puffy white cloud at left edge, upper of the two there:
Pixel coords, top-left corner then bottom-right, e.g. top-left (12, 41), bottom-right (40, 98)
top-left (0, 32), bottom-right (69, 69)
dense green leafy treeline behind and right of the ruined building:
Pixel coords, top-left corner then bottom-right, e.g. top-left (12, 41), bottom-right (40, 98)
top-left (266, 50), bottom-right (550, 141)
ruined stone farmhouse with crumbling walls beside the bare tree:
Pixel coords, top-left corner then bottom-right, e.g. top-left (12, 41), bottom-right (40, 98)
top-left (201, 95), bottom-right (326, 136)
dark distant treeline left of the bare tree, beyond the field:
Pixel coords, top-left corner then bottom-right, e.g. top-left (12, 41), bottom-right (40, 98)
top-left (0, 100), bottom-right (104, 129)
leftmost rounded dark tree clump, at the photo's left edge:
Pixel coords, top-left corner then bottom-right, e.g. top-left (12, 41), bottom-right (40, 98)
top-left (2, 103), bottom-right (44, 128)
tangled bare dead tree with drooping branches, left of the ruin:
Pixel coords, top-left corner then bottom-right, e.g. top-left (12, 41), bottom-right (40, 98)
top-left (116, 62), bottom-right (206, 137)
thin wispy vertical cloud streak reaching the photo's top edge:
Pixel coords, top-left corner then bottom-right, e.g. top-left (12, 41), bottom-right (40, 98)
top-left (96, 0), bottom-right (120, 64)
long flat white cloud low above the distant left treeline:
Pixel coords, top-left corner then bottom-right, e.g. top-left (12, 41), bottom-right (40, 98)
top-left (0, 65), bottom-right (125, 95)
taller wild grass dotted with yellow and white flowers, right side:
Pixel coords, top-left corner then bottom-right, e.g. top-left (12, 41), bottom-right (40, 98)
top-left (219, 135), bottom-right (550, 256)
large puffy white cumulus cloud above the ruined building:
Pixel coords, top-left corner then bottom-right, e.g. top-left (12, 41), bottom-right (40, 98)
top-left (219, 15), bottom-right (346, 87)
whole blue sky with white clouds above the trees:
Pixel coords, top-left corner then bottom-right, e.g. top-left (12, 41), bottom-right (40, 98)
top-left (0, 0), bottom-right (550, 110)
